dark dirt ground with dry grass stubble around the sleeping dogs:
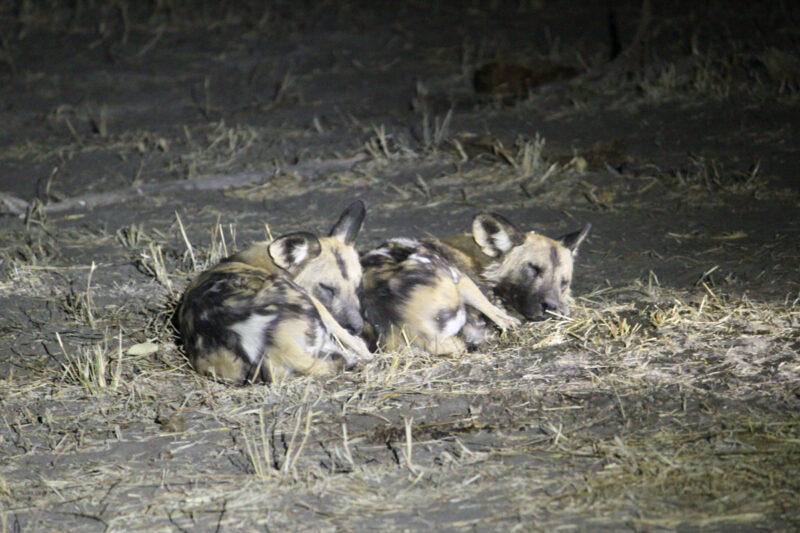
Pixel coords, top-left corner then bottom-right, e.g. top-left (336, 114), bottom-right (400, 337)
top-left (0, 0), bottom-right (800, 533)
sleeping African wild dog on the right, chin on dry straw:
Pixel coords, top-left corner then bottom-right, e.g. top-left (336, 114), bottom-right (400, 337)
top-left (361, 213), bottom-right (591, 354)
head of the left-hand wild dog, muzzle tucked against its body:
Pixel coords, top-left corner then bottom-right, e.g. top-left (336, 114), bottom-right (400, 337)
top-left (268, 200), bottom-right (365, 335)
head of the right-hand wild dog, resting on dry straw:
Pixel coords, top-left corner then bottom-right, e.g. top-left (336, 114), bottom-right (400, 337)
top-left (472, 213), bottom-right (591, 320)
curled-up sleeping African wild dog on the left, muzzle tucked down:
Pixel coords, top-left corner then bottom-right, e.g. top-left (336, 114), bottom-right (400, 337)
top-left (178, 200), bottom-right (370, 382)
